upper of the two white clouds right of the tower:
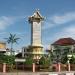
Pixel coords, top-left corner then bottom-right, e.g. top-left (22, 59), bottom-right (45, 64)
top-left (52, 12), bottom-right (75, 24)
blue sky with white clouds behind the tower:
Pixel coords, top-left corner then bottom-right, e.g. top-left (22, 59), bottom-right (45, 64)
top-left (0, 0), bottom-right (75, 50)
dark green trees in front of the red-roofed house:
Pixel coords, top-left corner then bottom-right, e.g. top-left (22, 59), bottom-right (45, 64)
top-left (51, 45), bottom-right (71, 64)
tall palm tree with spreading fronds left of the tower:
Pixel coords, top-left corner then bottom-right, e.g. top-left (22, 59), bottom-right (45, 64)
top-left (5, 33), bottom-right (20, 55)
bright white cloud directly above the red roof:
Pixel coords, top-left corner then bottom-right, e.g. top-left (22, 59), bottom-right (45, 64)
top-left (53, 25), bottom-right (75, 40)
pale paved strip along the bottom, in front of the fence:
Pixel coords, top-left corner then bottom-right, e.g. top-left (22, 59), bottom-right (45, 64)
top-left (0, 71), bottom-right (75, 75)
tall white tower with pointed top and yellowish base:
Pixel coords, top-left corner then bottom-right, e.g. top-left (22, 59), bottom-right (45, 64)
top-left (29, 10), bottom-right (44, 59)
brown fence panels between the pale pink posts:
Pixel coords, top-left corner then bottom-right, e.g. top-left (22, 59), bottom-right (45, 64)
top-left (0, 64), bottom-right (75, 72)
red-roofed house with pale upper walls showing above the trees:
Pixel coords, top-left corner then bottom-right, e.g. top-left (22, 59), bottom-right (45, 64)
top-left (51, 38), bottom-right (75, 50)
